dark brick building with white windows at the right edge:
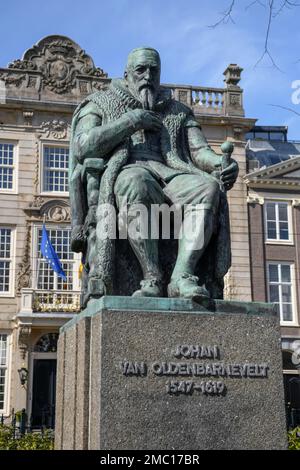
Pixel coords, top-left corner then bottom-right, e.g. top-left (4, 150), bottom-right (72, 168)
top-left (244, 126), bottom-right (300, 427)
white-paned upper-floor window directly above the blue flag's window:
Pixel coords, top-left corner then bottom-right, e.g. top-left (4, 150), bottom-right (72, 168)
top-left (43, 145), bottom-right (69, 193)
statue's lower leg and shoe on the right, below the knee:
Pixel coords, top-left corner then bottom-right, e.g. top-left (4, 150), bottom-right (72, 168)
top-left (168, 206), bottom-right (215, 301)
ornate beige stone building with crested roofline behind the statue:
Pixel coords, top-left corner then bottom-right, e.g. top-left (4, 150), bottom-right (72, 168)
top-left (0, 36), bottom-right (255, 427)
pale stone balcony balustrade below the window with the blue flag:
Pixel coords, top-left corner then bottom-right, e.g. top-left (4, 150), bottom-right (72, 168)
top-left (21, 289), bottom-right (80, 313)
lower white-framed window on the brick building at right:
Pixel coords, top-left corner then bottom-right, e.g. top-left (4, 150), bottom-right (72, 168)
top-left (268, 263), bottom-right (296, 323)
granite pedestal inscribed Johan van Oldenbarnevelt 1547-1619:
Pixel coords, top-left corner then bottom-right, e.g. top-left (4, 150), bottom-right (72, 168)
top-left (55, 296), bottom-right (287, 450)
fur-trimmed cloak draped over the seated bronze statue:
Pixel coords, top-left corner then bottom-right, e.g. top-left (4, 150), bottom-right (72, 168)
top-left (69, 80), bottom-right (231, 298)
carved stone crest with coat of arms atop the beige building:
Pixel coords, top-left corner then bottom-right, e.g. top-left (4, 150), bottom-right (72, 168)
top-left (4, 35), bottom-right (107, 94)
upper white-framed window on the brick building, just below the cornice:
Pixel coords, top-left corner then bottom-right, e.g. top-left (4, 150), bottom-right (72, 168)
top-left (265, 202), bottom-right (292, 242)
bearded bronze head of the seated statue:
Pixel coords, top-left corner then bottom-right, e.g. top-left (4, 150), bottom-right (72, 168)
top-left (124, 49), bottom-right (160, 110)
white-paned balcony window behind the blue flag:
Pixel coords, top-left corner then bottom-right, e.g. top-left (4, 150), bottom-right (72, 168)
top-left (37, 227), bottom-right (79, 291)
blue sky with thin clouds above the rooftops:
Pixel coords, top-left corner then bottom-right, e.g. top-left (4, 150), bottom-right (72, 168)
top-left (0, 0), bottom-right (300, 140)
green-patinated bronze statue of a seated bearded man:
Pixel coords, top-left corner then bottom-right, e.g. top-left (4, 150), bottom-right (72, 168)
top-left (69, 47), bottom-right (238, 305)
